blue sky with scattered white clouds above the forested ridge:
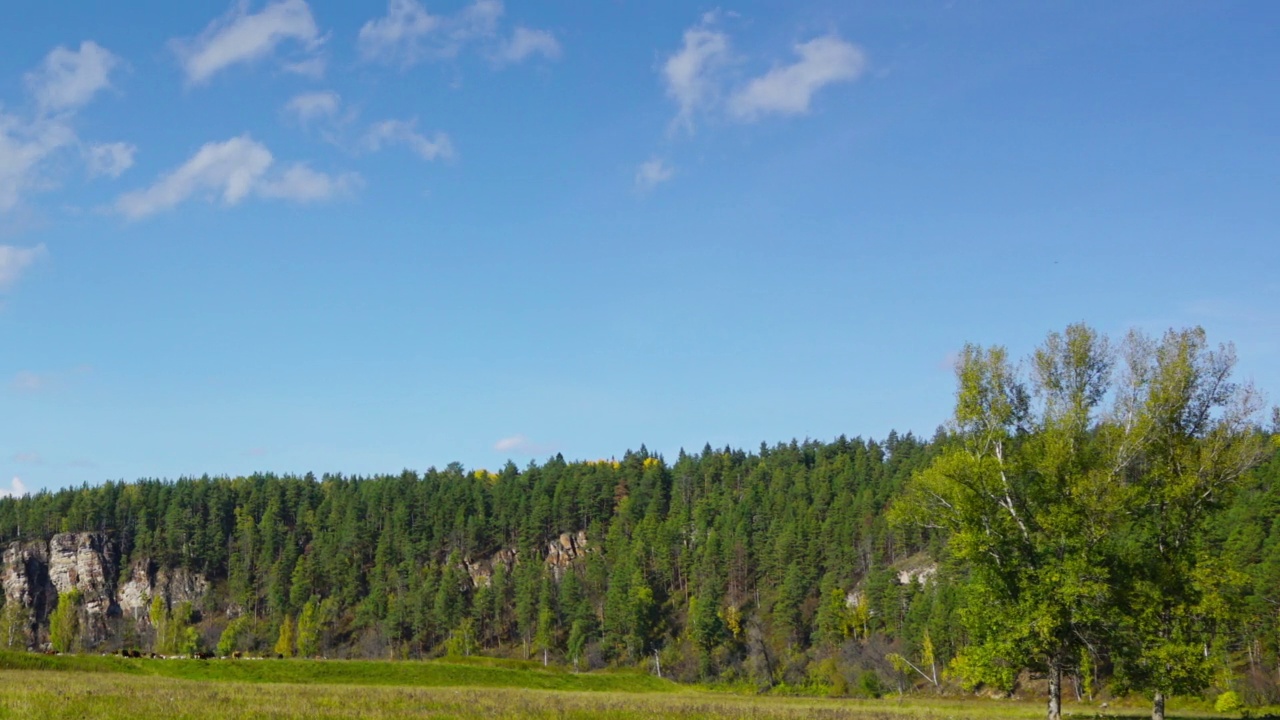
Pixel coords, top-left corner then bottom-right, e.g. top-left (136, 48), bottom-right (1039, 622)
top-left (0, 0), bottom-right (1280, 492)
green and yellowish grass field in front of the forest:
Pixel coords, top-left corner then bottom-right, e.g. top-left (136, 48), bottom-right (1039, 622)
top-left (0, 652), bottom-right (1249, 720)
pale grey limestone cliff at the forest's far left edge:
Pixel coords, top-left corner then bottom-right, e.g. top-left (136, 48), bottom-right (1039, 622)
top-left (0, 533), bottom-right (209, 647)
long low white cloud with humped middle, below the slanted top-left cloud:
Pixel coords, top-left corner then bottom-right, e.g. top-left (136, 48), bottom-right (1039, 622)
top-left (115, 135), bottom-right (358, 219)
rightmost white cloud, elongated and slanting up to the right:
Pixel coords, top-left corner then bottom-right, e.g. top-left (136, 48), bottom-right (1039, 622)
top-left (728, 36), bottom-right (867, 120)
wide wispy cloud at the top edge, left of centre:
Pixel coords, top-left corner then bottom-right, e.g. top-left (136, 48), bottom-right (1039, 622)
top-left (357, 0), bottom-right (561, 68)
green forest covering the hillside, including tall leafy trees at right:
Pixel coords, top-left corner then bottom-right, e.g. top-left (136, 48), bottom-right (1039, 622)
top-left (0, 325), bottom-right (1280, 716)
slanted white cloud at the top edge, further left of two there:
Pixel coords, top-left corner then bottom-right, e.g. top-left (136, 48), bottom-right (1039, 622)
top-left (172, 0), bottom-right (323, 83)
